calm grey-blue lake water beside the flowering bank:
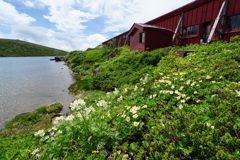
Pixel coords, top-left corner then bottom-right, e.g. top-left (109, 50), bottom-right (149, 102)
top-left (0, 57), bottom-right (74, 128)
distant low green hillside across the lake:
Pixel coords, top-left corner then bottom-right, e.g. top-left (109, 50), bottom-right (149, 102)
top-left (0, 39), bottom-right (67, 57)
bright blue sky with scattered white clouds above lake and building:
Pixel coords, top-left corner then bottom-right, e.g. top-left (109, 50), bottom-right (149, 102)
top-left (0, 0), bottom-right (193, 51)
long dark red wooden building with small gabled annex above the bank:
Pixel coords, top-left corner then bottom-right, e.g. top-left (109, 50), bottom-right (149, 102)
top-left (103, 0), bottom-right (240, 51)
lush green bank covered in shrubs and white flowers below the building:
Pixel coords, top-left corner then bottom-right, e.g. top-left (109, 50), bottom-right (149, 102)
top-left (0, 38), bottom-right (240, 160)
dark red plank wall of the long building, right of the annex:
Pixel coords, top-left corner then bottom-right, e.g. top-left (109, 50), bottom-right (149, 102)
top-left (148, 0), bottom-right (240, 45)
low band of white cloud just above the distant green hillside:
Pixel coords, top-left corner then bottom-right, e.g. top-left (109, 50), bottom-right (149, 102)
top-left (0, 25), bottom-right (106, 51)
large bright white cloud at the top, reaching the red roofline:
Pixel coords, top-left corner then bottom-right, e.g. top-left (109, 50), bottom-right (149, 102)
top-left (22, 0), bottom-right (193, 33)
